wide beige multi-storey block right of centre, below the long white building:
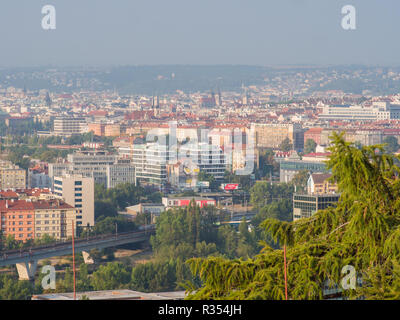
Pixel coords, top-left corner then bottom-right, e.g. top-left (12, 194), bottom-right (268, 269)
top-left (254, 123), bottom-right (304, 150)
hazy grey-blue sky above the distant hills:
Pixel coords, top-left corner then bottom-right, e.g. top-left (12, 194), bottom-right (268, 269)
top-left (0, 0), bottom-right (400, 66)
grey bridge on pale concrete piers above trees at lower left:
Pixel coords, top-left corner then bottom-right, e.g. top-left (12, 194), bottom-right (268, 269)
top-left (0, 229), bottom-right (154, 280)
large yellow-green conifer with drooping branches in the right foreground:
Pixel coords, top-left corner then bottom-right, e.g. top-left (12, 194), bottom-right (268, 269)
top-left (188, 134), bottom-right (400, 299)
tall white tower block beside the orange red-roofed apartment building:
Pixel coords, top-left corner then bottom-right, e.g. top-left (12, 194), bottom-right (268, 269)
top-left (54, 174), bottom-right (94, 227)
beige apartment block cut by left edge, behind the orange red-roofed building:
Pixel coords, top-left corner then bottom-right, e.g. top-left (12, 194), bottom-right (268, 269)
top-left (0, 161), bottom-right (26, 190)
